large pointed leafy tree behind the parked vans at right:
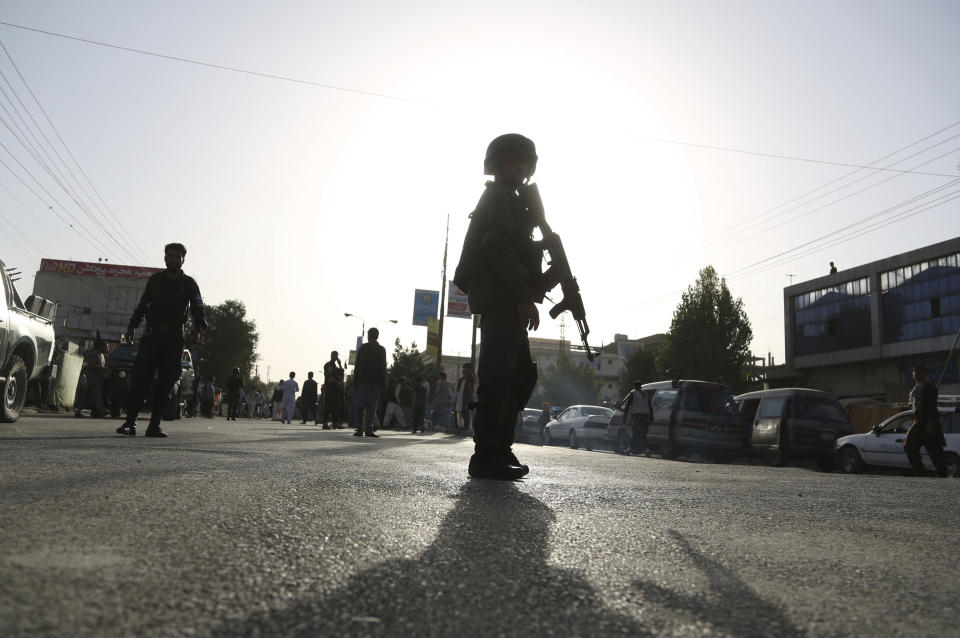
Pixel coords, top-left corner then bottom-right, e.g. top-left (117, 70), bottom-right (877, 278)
top-left (657, 266), bottom-right (753, 392)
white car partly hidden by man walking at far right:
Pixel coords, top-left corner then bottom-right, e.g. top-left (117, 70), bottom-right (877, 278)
top-left (836, 409), bottom-right (960, 477)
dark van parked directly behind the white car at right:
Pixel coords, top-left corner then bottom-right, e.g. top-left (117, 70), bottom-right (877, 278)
top-left (736, 388), bottom-right (853, 471)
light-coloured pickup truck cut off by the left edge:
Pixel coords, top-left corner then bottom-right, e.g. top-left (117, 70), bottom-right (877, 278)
top-left (0, 261), bottom-right (56, 423)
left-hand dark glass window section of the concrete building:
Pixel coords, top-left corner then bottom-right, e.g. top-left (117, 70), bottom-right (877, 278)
top-left (793, 277), bottom-right (872, 356)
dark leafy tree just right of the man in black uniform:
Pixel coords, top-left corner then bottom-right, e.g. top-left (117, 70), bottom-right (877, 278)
top-left (194, 299), bottom-right (258, 384)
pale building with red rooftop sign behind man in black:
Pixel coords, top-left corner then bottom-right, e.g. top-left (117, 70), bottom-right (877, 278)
top-left (33, 259), bottom-right (162, 343)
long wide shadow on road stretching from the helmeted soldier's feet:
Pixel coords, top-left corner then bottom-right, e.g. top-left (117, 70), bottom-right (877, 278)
top-left (214, 480), bottom-right (652, 637)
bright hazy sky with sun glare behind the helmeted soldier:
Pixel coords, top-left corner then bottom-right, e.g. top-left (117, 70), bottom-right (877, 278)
top-left (0, 0), bottom-right (960, 378)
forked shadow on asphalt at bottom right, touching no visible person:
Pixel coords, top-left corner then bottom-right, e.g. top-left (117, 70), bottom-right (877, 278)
top-left (633, 530), bottom-right (806, 638)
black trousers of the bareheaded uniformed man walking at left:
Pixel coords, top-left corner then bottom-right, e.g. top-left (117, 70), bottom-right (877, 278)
top-left (126, 331), bottom-right (183, 425)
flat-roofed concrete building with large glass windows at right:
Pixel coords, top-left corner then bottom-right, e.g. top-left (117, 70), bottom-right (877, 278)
top-left (770, 237), bottom-right (960, 401)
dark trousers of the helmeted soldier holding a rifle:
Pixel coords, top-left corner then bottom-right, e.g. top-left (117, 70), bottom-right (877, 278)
top-left (473, 303), bottom-right (537, 458)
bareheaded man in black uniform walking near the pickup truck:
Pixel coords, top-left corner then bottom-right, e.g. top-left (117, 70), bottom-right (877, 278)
top-left (117, 243), bottom-right (207, 437)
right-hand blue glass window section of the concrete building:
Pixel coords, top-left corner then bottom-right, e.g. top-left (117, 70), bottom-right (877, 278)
top-left (880, 253), bottom-right (960, 343)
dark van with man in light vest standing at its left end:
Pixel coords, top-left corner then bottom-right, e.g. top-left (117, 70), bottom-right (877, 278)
top-left (642, 380), bottom-right (749, 459)
